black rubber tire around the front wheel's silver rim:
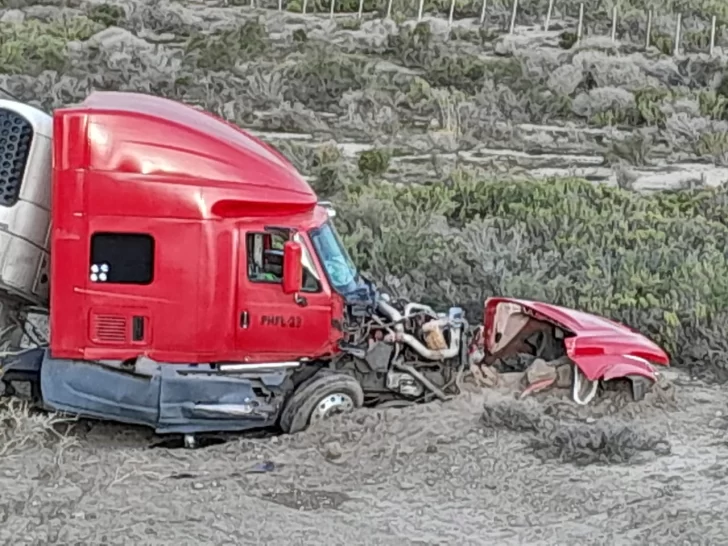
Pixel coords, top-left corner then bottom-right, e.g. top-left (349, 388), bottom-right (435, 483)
top-left (280, 370), bottom-right (364, 434)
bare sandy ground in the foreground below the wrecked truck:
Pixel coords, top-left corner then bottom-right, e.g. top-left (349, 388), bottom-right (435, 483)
top-left (0, 370), bottom-right (728, 546)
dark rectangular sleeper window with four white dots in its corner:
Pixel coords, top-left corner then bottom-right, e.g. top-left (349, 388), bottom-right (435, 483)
top-left (89, 233), bottom-right (154, 284)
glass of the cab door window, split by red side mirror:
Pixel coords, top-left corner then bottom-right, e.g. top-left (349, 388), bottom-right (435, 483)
top-left (245, 232), bottom-right (321, 292)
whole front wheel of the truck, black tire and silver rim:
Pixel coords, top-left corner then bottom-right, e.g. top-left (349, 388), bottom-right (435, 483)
top-left (280, 372), bottom-right (364, 434)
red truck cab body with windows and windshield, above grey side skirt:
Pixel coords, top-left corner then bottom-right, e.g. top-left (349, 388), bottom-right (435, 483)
top-left (50, 92), bottom-right (358, 363)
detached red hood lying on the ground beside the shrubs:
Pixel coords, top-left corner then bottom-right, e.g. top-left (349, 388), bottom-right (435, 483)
top-left (485, 297), bottom-right (670, 381)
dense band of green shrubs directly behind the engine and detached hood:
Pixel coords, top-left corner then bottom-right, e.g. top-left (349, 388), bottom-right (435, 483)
top-left (324, 173), bottom-right (728, 380)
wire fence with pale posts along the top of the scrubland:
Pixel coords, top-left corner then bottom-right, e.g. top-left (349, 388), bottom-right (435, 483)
top-left (242, 0), bottom-right (728, 56)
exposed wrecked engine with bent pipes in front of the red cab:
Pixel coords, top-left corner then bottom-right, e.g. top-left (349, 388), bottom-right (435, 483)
top-left (335, 294), bottom-right (467, 405)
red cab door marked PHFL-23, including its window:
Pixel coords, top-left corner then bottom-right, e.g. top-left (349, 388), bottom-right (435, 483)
top-left (235, 229), bottom-right (332, 361)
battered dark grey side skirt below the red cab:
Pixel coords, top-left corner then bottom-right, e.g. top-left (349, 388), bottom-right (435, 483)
top-left (40, 353), bottom-right (285, 434)
